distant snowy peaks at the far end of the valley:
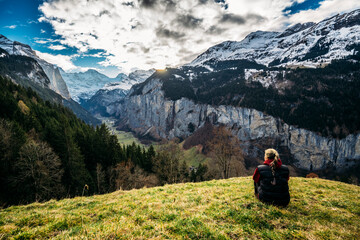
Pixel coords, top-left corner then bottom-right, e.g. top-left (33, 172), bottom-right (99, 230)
top-left (61, 69), bottom-right (154, 103)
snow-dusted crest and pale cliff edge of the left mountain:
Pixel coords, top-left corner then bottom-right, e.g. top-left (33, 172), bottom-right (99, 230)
top-left (0, 34), bottom-right (70, 99)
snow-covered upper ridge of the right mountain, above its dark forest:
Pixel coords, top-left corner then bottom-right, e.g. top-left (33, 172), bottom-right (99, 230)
top-left (190, 9), bottom-right (360, 69)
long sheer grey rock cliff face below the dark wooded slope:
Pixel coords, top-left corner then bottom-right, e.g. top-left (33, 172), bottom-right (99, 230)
top-left (116, 79), bottom-right (360, 170)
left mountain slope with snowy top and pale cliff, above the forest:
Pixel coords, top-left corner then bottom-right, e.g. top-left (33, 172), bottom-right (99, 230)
top-left (0, 35), bottom-right (101, 125)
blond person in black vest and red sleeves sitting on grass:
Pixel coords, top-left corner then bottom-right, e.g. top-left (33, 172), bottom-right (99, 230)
top-left (253, 148), bottom-right (290, 206)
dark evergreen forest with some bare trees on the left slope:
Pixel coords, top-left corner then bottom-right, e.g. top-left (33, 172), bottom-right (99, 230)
top-left (0, 76), bottom-right (206, 207)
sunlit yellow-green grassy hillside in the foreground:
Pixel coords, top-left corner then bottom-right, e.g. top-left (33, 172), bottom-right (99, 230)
top-left (0, 177), bottom-right (360, 239)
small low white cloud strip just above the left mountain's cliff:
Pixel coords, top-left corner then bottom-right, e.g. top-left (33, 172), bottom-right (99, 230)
top-left (35, 51), bottom-right (87, 72)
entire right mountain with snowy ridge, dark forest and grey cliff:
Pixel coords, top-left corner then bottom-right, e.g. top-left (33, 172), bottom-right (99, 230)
top-left (113, 10), bottom-right (360, 171)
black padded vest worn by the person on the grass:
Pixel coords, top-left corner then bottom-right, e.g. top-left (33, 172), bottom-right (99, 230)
top-left (255, 165), bottom-right (290, 206)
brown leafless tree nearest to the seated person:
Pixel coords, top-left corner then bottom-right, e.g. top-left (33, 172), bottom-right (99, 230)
top-left (209, 126), bottom-right (245, 178)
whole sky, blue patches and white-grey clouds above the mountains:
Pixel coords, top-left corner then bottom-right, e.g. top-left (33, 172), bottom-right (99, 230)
top-left (0, 0), bottom-right (360, 77)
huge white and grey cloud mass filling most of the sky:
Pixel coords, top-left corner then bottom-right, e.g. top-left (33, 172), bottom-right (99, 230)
top-left (39, 0), bottom-right (360, 71)
